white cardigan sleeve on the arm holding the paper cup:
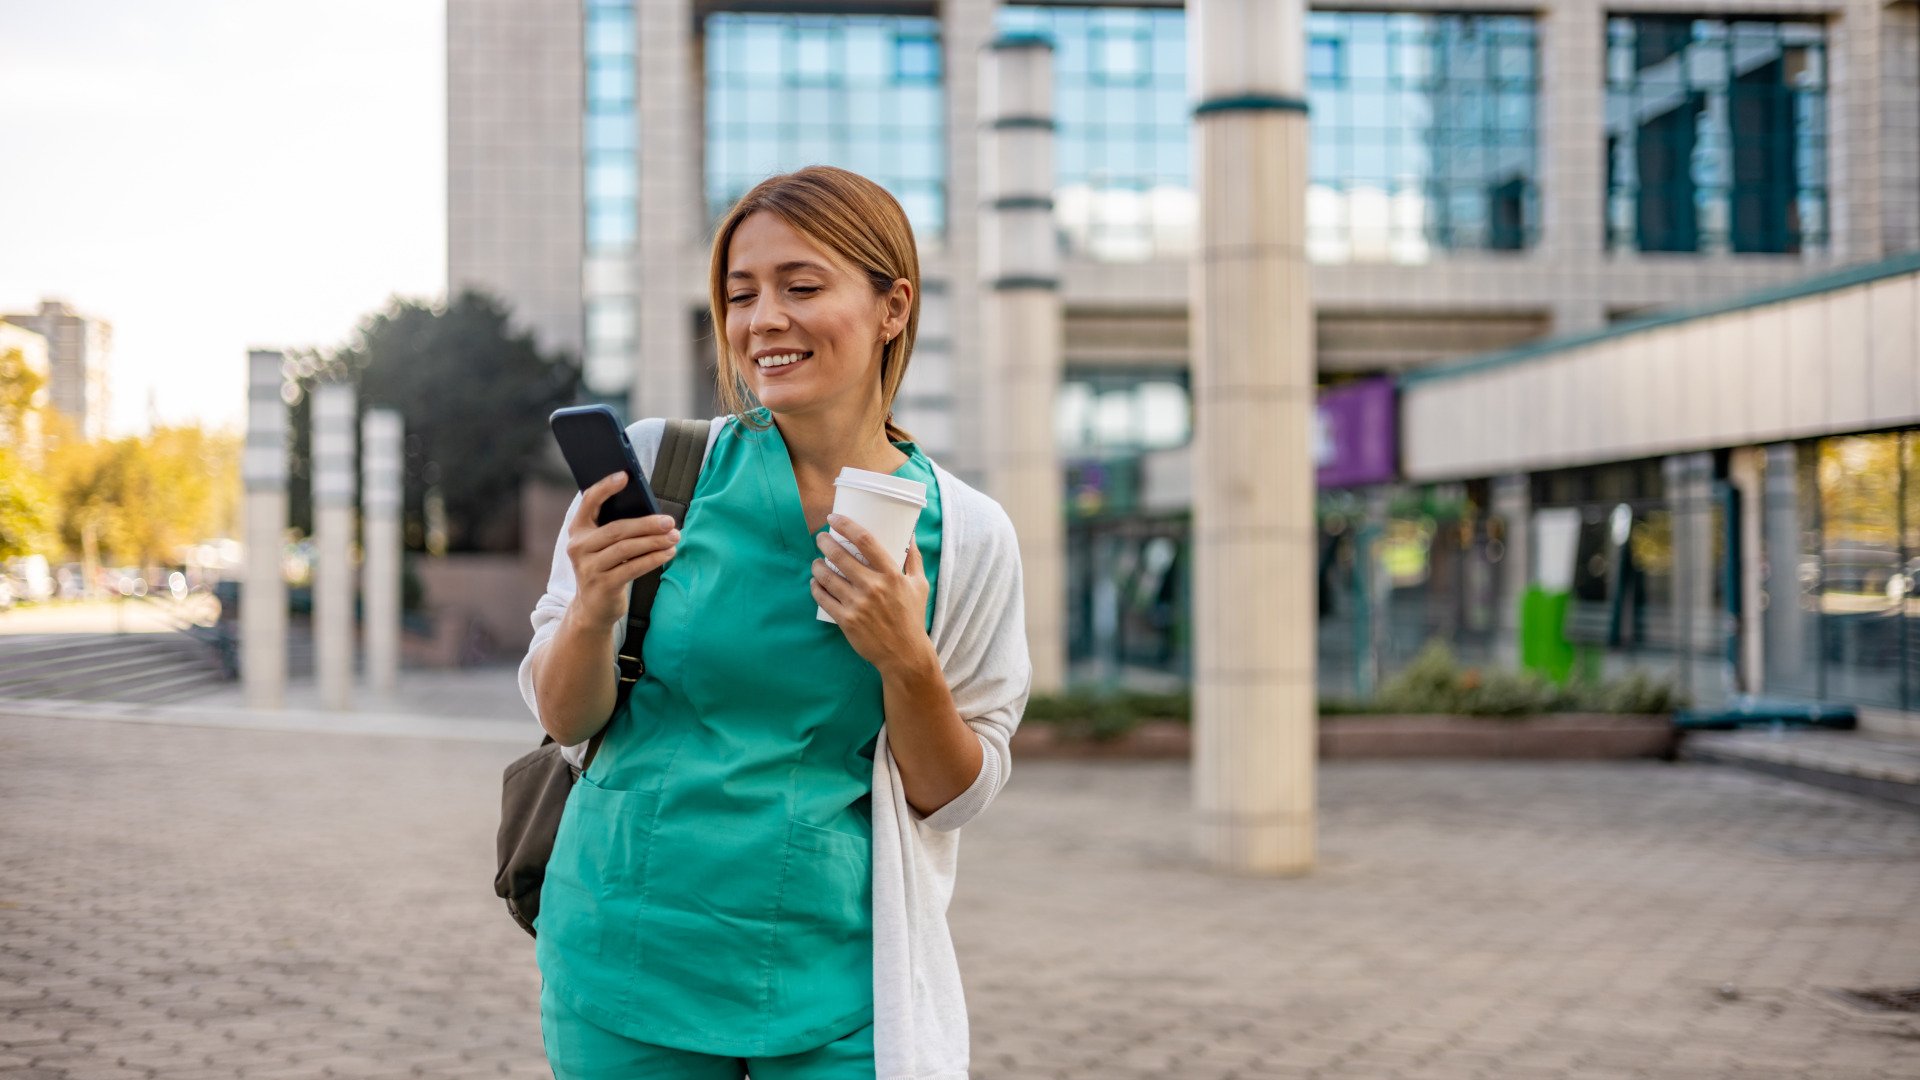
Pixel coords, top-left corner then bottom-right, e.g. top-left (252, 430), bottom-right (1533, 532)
top-left (906, 490), bottom-right (1033, 832)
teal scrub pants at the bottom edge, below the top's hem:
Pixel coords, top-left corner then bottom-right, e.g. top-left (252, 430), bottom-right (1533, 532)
top-left (540, 982), bottom-right (874, 1080)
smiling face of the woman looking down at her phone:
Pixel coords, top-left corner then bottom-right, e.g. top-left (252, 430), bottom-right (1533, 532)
top-left (726, 211), bottom-right (912, 421)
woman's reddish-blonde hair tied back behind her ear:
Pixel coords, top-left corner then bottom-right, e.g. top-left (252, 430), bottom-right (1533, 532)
top-left (708, 165), bottom-right (920, 442)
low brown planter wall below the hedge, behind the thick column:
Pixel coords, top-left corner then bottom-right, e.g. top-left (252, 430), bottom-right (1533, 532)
top-left (1014, 713), bottom-right (1680, 761)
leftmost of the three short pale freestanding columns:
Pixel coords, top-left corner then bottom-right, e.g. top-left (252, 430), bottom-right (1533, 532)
top-left (240, 350), bottom-right (286, 709)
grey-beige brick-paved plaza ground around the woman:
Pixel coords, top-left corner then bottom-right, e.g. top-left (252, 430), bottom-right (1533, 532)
top-left (0, 707), bottom-right (1920, 1080)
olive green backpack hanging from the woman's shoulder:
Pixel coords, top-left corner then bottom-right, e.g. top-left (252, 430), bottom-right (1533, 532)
top-left (493, 421), bottom-right (710, 934)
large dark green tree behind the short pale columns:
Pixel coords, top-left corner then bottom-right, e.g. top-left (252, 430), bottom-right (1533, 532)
top-left (288, 292), bottom-right (580, 552)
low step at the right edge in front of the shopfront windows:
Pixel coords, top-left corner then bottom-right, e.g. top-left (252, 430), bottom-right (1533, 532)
top-left (1680, 728), bottom-right (1920, 809)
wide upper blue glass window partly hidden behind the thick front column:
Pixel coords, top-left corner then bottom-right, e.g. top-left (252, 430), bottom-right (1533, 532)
top-left (996, 6), bottom-right (1540, 263)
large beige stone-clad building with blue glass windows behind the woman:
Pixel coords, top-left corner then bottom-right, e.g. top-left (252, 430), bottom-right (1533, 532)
top-left (447, 0), bottom-right (1920, 711)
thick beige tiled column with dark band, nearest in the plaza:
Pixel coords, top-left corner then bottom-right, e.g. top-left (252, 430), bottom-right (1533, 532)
top-left (1187, 0), bottom-right (1317, 874)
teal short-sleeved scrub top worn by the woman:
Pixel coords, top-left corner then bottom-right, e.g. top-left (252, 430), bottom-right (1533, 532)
top-left (536, 409), bottom-right (941, 1057)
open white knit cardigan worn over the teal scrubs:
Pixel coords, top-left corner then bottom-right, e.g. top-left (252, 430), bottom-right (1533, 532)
top-left (520, 417), bottom-right (1033, 1080)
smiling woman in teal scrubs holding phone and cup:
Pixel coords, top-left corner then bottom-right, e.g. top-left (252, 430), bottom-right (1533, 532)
top-left (520, 167), bottom-right (1031, 1080)
